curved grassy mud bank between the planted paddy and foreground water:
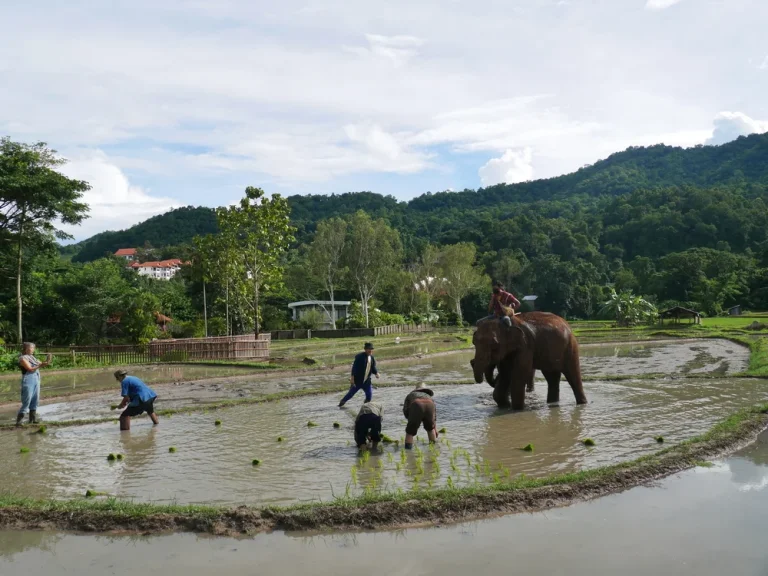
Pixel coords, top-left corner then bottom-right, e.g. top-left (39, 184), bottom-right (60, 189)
top-left (0, 405), bottom-right (768, 535)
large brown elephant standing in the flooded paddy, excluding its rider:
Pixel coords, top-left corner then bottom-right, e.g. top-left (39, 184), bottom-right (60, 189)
top-left (470, 312), bottom-right (587, 410)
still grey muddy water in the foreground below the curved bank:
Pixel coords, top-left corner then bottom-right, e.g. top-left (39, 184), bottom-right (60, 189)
top-left (0, 436), bottom-right (768, 576)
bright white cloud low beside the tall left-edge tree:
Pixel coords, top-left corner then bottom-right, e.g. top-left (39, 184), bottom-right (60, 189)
top-left (60, 151), bottom-right (182, 240)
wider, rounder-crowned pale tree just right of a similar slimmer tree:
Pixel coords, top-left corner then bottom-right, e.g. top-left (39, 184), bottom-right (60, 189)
top-left (344, 210), bottom-right (402, 328)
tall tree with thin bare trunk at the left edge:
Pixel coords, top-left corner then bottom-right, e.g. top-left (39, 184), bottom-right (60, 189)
top-left (0, 138), bottom-right (90, 344)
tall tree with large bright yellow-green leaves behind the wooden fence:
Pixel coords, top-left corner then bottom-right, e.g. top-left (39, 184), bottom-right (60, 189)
top-left (216, 186), bottom-right (295, 335)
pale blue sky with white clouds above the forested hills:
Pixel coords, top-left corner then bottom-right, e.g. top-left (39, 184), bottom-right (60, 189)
top-left (0, 0), bottom-right (768, 240)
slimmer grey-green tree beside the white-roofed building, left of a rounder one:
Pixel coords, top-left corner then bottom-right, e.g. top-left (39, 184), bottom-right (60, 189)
top-left (309, 218), bottom-right (347, 330)
